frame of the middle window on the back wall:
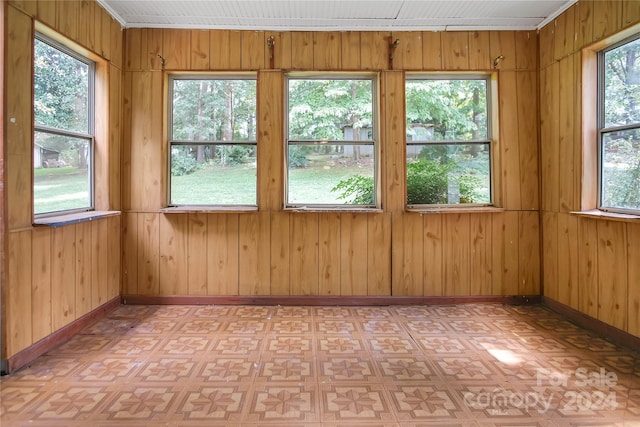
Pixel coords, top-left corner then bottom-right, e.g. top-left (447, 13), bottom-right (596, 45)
top-left (283, 71), bottom-right (381, 211)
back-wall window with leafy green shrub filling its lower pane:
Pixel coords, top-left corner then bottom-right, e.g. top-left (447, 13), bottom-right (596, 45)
top-left (406, 74), bottom-right (492, 208)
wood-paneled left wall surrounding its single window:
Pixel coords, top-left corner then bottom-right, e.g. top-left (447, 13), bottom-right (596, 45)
top-left (1, 0), bottom-right (124, 359)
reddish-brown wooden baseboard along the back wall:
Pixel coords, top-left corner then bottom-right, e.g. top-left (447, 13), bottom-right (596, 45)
top-left (122, 295), bottom-right (540, 306)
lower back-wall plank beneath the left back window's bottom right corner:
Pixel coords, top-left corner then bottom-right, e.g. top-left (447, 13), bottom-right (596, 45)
top-left (239, 212), bottom-right (271, 295)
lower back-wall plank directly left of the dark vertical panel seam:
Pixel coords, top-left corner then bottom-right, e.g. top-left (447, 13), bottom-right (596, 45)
top-left (367, 213), bottom-right (391, 296)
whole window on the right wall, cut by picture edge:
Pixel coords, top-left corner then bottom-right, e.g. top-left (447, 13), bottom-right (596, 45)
top-left (598, 35), bottom-right (640, 213)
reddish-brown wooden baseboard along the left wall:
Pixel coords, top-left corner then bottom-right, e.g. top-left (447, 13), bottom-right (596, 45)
top-left (3, 297), bottom-right (120, 374)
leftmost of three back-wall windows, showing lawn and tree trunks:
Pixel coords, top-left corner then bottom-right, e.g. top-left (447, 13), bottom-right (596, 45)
top-left (168, 75), bottom-right (257, 206)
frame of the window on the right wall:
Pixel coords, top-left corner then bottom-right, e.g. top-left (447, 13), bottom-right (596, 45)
top-left (596, 32), bottom-right (640, 215)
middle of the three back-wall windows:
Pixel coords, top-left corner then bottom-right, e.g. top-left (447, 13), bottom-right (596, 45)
top-left (286, 74), bottom-right (378, 208)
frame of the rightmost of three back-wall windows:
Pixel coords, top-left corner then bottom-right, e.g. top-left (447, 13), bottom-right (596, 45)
top-left (404, 72), bottom-right (498, 211)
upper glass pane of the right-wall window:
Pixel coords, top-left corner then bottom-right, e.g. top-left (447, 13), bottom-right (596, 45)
top-left (604, 39), bottom-right (640, 128)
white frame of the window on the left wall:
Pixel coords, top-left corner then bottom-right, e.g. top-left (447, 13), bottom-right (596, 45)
top-left (31, 30), bottom-right (97, 221)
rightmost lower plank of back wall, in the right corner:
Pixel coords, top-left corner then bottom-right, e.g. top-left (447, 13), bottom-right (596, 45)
top-left (518, 212), bottom-right (540, 295)
